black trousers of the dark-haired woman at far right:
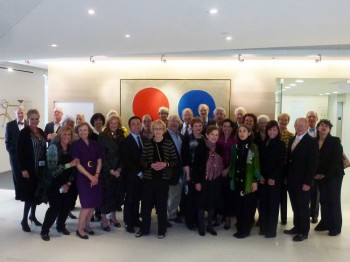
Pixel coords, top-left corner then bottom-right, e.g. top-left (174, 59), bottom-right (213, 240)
top-left (319, 175), bottom-right (343, 233)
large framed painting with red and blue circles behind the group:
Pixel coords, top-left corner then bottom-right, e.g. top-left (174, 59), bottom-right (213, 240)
top-left (120, 79), bottom-right (231, 120)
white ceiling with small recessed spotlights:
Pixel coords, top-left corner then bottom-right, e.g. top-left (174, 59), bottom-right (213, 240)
top-left (0, 0), bottom-right (350, 68)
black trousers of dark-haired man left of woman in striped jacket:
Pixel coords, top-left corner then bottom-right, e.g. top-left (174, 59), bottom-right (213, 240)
top-left (124, 177), bottom-right (142, 227)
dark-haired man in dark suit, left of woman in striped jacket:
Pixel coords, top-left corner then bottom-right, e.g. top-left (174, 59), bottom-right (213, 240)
top-left (120, 116), bottom-right (143, 233)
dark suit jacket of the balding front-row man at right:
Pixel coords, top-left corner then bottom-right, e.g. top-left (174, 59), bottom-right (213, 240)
top-left (287, 133), bottom-right (319, 188)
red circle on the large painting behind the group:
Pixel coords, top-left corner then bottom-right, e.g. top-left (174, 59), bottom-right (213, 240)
top-left (132, 87), bottom-right (169, 119)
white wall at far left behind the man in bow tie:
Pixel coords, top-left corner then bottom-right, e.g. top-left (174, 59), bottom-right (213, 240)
top-left (0, 65), bottom-right (45, 173)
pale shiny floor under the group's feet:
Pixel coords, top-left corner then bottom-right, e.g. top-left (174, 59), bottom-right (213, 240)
top-left (0, 175), bottom-right (350, 262)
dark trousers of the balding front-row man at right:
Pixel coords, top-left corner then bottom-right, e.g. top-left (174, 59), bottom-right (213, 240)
top-left (288, 185), bottom-right (311, 235)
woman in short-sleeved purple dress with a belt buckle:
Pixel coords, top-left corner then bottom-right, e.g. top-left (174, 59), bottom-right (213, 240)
top-left (72, 122), bottom-right (102, 239)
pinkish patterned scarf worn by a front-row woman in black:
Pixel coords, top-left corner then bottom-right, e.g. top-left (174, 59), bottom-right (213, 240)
top-left (205, 140), bottom-right (224, 181)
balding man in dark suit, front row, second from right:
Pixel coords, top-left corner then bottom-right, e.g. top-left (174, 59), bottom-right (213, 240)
top-left (284, 118), bottom-right (319, 241)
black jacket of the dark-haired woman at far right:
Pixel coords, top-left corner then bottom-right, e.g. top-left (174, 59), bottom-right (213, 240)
top-left (316, 134), bottom-right (344, 179)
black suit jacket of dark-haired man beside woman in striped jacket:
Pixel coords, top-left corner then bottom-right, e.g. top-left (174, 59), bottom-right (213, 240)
top-left (120, 134), bottom-right (142, 183)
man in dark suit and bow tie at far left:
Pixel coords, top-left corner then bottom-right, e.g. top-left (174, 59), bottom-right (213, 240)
top-left (5, 107), bottom-right (28, 200)
